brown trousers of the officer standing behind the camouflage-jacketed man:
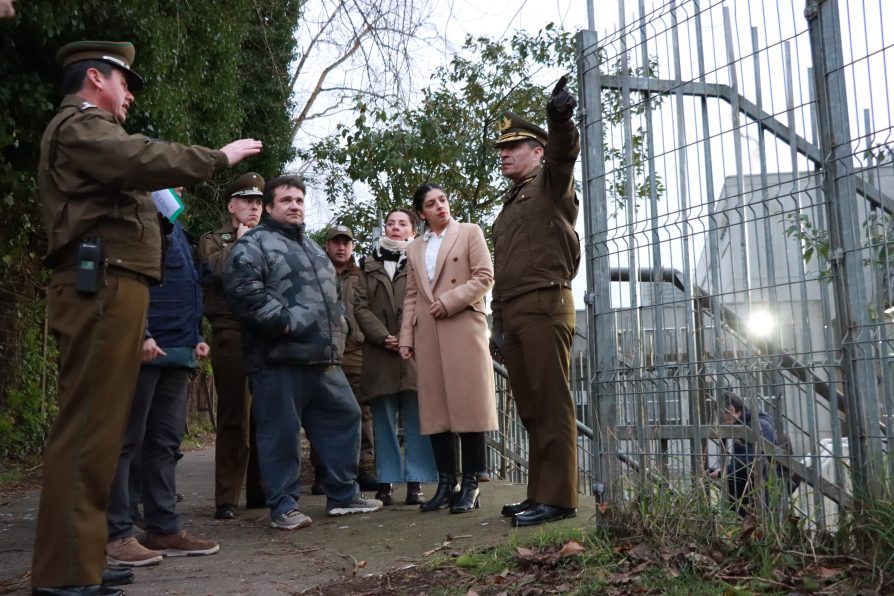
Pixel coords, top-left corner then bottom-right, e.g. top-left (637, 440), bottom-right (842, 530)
top-left (211, 326), bottom-right (263, 506)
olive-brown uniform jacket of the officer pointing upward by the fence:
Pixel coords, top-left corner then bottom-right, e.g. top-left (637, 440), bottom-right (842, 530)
top-left (491, 120), bottom-right (580, 319)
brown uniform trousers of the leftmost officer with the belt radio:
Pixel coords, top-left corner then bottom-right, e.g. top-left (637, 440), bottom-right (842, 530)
top-left (31, 271), bottom-right (149, 587)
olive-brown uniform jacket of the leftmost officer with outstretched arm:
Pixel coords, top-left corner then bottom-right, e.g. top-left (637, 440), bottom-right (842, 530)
top-left (37, 95), bottom-right (228, 280)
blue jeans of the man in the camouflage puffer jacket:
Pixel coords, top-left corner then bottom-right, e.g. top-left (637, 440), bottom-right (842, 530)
top-left (251, 366), bottom-right (360, 517)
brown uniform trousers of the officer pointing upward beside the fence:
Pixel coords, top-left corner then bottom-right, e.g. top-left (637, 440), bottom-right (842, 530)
top-left (503, 288), bottom-right (578, 507)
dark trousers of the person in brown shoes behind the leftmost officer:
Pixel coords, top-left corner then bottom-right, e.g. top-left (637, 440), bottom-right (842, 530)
top-left (106, 365), bottom-right (192, 540)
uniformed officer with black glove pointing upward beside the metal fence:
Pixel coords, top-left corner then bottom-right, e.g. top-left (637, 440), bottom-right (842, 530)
top-left (491, 77), bottom-right (580, 526)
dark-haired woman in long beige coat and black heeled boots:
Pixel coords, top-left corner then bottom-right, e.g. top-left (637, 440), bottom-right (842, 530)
top-left (399, 184), bottom-right (497, 513)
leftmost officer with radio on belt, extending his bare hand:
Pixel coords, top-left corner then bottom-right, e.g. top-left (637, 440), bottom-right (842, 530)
top-left (31, 41), bottom-right (261, 595)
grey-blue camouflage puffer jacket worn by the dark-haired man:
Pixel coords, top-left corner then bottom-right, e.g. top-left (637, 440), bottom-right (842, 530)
top-left (223, 219), bottom-right (348, 373)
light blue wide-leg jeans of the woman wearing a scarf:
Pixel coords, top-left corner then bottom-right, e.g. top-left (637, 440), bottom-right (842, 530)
top-left (369, 391), bottom-right (438, 483)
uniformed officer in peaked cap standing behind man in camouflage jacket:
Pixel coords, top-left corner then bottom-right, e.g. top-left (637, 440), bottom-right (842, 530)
top-left (198, 172), bottom-right (265, 520)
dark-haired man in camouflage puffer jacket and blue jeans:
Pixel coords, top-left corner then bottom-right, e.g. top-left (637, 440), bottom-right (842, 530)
top-left (223, 176), bottom-right (382, 530)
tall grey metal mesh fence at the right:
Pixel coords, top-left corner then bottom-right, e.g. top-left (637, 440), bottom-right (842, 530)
top-left (578, 0), bottom-right (894, 527)
